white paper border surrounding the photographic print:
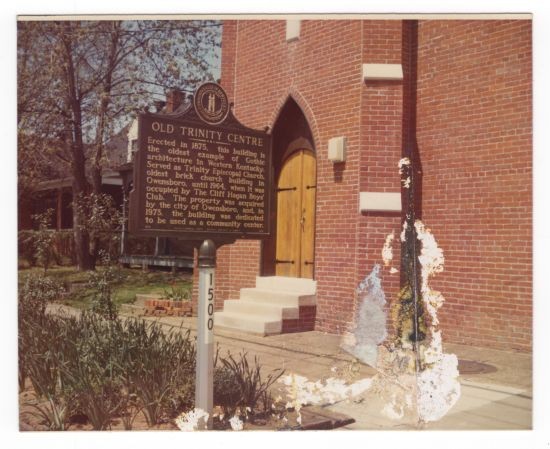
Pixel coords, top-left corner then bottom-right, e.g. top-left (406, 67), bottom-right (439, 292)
top-left (0, 0), bottom-right (550, 449)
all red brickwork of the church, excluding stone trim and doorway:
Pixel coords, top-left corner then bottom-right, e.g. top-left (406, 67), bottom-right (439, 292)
top-left (209, 20), bottom-right (532, 350)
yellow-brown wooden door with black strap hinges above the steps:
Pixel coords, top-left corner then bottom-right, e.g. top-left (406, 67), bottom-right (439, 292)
top-left (275, 150), bottom-right (317, 279)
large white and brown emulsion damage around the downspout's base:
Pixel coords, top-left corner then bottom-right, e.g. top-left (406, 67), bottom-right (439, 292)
top-left (342, 158), bottom-right (460, 424)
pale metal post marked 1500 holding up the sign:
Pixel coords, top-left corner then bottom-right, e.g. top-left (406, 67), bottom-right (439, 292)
top-left (195, 240), bottom-right (216, 429)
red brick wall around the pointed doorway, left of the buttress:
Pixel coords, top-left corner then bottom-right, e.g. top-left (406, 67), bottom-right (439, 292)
top-left (218, 20), bottom-right (370, 332)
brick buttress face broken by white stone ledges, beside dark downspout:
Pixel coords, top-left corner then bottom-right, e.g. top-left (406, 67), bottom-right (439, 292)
top-left (357, 20), bottom-right (403, 324)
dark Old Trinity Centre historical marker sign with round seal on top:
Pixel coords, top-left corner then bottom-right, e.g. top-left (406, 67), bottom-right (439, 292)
top-left (129, 83), bottom-right (271, 239)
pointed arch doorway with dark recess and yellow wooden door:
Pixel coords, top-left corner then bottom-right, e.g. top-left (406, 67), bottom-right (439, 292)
top-left (261, 97), bottom-right (317, 279)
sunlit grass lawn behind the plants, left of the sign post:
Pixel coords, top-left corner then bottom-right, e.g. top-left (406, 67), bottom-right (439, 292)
top-left (19, 266), bottom-right (192, 309)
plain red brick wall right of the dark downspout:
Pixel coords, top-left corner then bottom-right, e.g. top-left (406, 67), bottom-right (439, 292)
top-left (417, 21), bottom-right (532, 350)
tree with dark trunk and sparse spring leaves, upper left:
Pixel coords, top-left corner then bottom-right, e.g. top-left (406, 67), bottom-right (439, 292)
top-left (18, 20), bottom-right (220, 270)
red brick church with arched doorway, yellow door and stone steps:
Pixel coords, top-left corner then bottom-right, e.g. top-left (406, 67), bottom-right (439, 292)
top-left (204, 16), bottom-right (532, 351)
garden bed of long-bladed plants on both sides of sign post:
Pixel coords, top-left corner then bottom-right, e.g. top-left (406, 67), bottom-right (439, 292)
top-left (18, 277), bottom-right (282, 430)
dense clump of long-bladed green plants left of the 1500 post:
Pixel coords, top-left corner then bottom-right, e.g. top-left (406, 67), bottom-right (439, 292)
top-left (20, 306), bottom-right (195, 430)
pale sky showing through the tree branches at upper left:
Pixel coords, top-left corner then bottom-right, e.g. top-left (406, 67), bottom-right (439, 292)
top-left (19, 16), bottom-right (222, 144)
